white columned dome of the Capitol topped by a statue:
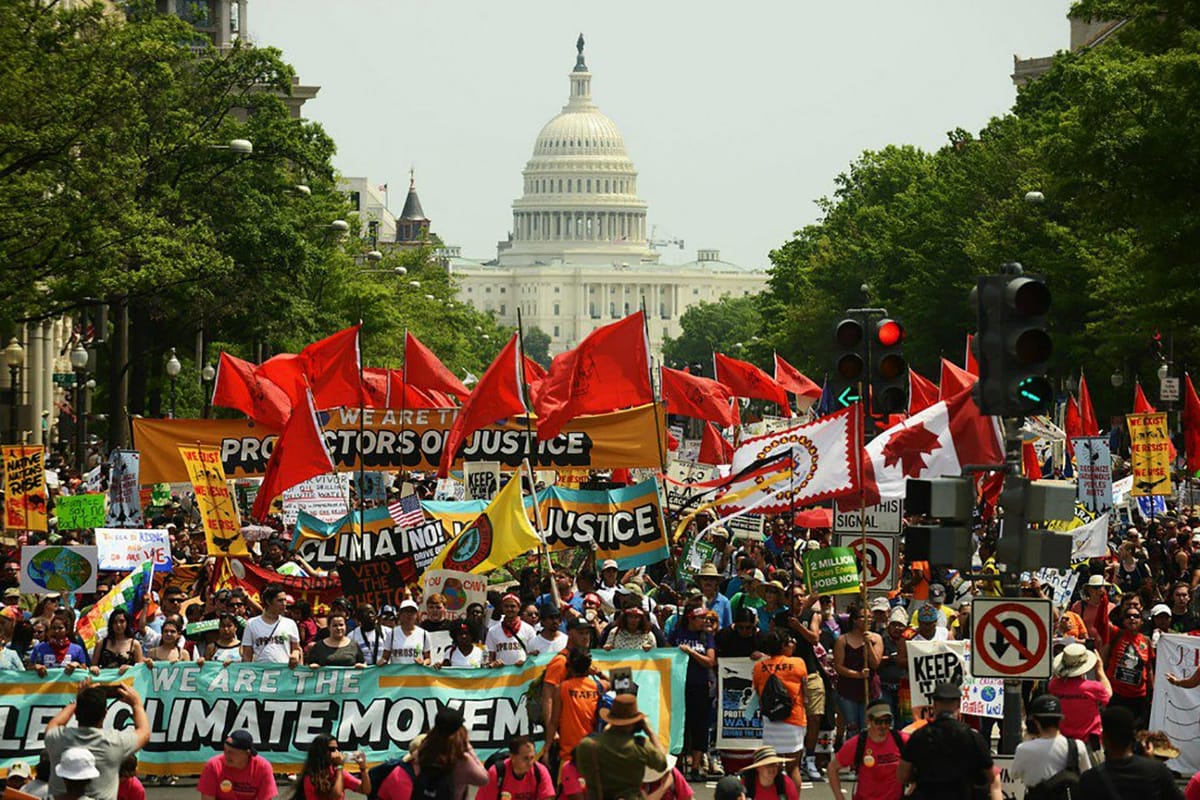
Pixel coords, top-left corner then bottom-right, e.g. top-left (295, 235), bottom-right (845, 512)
top-left (499, 35), bottom-right (658, 265)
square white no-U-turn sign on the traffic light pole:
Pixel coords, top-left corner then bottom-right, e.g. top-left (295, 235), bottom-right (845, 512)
top-left (971, 597), bottom-right (1052, 680)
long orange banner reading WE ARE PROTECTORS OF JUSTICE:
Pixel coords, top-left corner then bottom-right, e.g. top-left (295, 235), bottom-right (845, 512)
top-left (133, 405), bottom-right (667, 483)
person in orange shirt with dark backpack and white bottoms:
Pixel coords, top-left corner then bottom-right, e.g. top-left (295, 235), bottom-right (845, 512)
top-left (751, 630), bottom-right (809, 786)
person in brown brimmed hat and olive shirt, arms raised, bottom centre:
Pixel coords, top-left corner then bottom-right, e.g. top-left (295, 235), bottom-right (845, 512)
top-left (563, 694), bottom-right (667, 800)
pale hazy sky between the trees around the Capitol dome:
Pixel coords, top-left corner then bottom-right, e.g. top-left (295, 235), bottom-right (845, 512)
top-left (248, 0), bottom-right (1070, 267)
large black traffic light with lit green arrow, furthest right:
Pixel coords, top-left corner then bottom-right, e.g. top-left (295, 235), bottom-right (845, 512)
top-left (971, 264), bottom-right (1054, 417)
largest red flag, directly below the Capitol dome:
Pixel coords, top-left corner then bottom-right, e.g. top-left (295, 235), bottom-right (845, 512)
top-left (532, 311), bottom-right (654, 439)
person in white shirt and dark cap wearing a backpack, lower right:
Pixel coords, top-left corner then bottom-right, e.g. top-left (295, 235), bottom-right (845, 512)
top-left (1008, 694), bottom-right (1092, 800)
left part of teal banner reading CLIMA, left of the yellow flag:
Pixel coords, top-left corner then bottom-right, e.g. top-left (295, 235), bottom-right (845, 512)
top-left (292, 506), bottom-right (448, 573)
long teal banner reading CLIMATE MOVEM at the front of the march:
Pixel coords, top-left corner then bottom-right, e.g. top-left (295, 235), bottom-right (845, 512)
top-left (0, 649), bottom-right (688, 775)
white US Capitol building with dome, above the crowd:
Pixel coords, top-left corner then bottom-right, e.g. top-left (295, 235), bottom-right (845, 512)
top-left (442, 35), bottom-right (768, 357)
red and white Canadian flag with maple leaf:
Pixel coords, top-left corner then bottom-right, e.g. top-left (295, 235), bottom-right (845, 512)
top-left (854, 389), bottom-right (1004, 505)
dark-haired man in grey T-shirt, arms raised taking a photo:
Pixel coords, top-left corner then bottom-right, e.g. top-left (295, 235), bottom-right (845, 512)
top-left (46, 680), bottom-right (150, 800)
